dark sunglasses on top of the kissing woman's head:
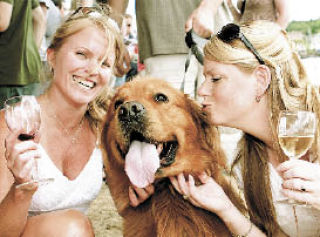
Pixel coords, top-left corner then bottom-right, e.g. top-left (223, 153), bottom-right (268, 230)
top-left (217, 23), bottom-right (266, 65)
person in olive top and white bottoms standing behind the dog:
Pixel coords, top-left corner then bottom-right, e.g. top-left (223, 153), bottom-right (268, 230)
top-left (108, 0), bottom-right (232, 97)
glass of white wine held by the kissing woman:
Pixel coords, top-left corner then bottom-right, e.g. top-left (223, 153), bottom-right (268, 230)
top-left (278, 111), bottom-right (317, 204)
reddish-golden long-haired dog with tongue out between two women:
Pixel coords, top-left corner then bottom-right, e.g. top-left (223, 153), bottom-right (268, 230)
top-left (101, 77), bottom-right (241, 237)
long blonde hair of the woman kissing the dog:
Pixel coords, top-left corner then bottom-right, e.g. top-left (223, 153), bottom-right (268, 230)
top-left (204, 21), bottom-right (320, 236)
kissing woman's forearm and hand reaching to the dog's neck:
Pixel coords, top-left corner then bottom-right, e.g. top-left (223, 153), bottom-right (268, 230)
top-left (170, 173), bottom-right (266, 237)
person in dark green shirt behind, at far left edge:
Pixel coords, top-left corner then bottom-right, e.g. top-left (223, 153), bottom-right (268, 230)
top-left (0, 0), bottom-right (46, 108)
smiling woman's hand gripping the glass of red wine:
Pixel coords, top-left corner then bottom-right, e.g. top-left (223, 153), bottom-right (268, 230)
top-left (5, 130), bottom-right (40, 188)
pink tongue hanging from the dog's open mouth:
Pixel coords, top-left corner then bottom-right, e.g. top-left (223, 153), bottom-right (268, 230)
top-left (125, 141), bottom-right (160, 188)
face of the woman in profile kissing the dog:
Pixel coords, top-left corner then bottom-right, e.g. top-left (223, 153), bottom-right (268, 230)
top-left (198, 58), bottom-right (257, 127)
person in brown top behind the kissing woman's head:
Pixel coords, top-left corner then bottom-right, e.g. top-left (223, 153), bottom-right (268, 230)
top-left (228, 0), bottom-right (290, 30)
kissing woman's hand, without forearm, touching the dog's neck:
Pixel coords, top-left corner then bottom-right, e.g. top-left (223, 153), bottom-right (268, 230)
top-left (170, 173), bottom-right (232, 216)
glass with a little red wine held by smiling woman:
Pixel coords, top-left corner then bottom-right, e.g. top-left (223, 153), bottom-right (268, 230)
top-left (4, 95), bottom-right (54, 187)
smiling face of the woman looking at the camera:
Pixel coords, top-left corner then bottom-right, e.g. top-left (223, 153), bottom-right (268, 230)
top-left (48, 27), bottom-right (115, 105)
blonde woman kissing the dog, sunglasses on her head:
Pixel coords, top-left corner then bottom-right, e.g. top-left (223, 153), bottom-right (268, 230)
top-left (171, 21), bottom-right (320, 237)
